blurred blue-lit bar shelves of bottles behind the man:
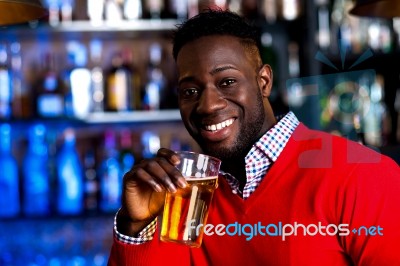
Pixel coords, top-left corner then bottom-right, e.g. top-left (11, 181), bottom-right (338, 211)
top-left (0, 0), bottom-right (400, 266)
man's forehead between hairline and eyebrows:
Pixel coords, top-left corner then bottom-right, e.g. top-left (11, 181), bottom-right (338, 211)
top-left (177, 35), bottom-right (254, 70)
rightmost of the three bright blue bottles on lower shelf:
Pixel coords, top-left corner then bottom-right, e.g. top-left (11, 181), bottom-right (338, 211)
top-left (56, 128), bottom-right (84, 215)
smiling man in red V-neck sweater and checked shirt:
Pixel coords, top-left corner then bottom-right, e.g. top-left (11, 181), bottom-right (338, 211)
top-left (109, 10), bottom-right (400, 265)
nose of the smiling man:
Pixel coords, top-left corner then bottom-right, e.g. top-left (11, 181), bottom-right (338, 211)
top-left (197, 86), bottom-right (227, 114)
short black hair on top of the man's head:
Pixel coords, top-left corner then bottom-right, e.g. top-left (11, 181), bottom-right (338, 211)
top-left (172, 9), bottom-right (261, 61)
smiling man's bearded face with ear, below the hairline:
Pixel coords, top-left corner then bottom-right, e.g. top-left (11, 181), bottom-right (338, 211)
top-left (177, 36), bottom-right (272, 159)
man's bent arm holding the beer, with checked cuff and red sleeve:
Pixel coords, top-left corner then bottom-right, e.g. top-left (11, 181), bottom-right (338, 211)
top-left (108, 149), bottom-right (189, 265)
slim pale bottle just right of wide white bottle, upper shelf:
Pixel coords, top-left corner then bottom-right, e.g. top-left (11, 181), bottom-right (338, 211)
top-left (90, 39), bottom-right (104, 113)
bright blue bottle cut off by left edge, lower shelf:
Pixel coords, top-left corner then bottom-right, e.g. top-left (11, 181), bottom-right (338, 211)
top-left (0, 124), bottom-right (20, 218)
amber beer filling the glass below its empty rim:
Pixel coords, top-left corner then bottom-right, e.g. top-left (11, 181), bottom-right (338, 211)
top-left (160, 176), bottom-right (218, 247)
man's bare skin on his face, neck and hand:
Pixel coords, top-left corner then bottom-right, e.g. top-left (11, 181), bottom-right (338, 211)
top-left (117, 36), bottom-right (276, 236)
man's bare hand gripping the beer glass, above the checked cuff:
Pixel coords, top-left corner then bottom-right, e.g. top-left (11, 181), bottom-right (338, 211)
top-left (117, 148), bottom-right (187, 236)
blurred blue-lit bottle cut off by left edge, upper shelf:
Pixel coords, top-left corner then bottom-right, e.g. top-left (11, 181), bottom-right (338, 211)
top-left (0, 43), bottom-right (12, 119)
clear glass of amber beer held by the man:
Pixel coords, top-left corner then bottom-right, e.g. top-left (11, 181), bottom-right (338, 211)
top-left (160, 151), bottom-right (221, 247)
